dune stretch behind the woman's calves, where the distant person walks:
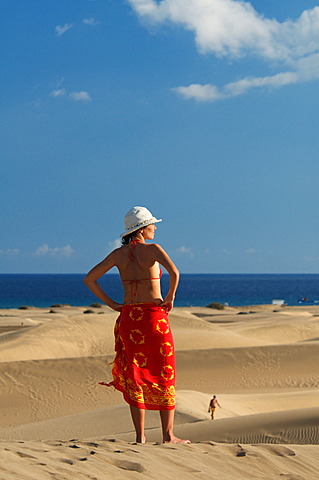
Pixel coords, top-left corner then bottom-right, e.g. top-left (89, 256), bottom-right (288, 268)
top-left (0, 390), bottom-right (319, 444)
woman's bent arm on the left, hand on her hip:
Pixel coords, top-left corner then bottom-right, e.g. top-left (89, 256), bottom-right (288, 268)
top-left (83, 251), bottom-right (123, 312)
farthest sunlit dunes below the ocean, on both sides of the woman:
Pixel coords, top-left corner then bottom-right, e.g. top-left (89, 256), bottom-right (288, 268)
top-left (0, 307), bottom-right (319, 362)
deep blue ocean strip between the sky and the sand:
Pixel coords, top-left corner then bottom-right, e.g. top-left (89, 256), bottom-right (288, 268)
top-left (0, 274), bottom-right (319, 308)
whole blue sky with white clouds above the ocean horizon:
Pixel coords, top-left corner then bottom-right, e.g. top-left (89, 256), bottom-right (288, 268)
top-left (0, 0), bottom-right (319, 273)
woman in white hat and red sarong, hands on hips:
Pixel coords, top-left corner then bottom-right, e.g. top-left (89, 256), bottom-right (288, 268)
top-left (84, 207), bottom-right (190, 443)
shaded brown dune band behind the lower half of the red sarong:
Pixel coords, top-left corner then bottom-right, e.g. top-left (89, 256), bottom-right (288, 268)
top-left (0, 343), bottom-right (319, 425)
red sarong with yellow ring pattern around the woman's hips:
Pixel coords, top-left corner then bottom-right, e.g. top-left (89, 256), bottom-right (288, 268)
top-left (101, 303), bottom-right (175, 410)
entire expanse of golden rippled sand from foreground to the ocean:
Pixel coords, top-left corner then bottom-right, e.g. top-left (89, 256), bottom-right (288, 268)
top-left (0, 305), bottom-right (319, 480)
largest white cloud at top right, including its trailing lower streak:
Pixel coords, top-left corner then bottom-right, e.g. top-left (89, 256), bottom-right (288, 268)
top-left (128, 0), bottom-right (319, 101)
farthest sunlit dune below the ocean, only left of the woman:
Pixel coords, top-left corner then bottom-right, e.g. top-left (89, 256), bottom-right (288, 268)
top-left (0, 309), bottom-right (116, 362)
